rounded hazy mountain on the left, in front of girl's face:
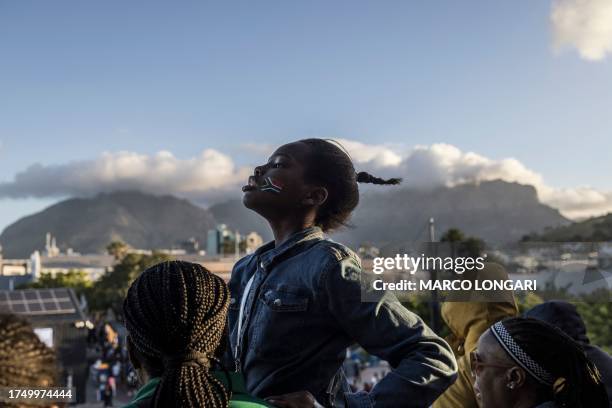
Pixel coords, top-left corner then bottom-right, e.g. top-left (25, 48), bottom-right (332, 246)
top-left (0, 191), bottom-right (216, 258)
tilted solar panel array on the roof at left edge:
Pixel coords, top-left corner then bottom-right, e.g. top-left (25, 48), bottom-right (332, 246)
top-left (0, 288), bottom-right (77, 316)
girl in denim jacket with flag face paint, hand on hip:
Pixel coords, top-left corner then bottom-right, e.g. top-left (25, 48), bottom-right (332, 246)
top-left (229, 139), bottom-right (456, 408)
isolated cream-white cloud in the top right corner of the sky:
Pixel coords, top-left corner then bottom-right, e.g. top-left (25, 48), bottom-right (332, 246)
top-left (550, 0), bottom-right (612, 61)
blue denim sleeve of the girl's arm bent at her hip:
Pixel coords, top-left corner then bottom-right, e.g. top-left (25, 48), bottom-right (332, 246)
top-left (321, 255), bottom-right (457, 408)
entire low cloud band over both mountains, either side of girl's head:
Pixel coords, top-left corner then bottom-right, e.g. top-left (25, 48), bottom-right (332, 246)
top-left (0, 139), bottom-right (612, 222)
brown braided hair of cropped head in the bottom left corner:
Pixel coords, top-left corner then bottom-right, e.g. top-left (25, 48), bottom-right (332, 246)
top-left (0, 314), bottom-right (57, 404)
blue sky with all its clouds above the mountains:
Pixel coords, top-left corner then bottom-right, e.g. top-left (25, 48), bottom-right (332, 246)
top-left (0, 0), bottom-right (612, 231)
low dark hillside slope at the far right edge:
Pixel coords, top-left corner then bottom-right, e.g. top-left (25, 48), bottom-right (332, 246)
top-left (525, 213), bottom-right (612, 242)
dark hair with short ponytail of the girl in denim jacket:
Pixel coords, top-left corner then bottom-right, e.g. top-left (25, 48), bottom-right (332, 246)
top-left (299, 139), bottom-right (402, 231)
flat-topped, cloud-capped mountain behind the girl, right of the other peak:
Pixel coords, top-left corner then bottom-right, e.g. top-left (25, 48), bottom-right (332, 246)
top-left (210, 180), bottom-right (569, 248)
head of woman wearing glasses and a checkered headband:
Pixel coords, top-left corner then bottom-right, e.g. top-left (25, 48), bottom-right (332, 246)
top-left (470, 317), bottom-right (608, 408)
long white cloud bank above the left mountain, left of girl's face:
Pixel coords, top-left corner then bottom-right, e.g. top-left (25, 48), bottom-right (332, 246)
top-left (0, 149), bottom-right (249, 200)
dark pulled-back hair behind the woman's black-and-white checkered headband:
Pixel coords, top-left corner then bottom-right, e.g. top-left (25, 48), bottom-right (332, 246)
top-left (503, 317), bottom-right (608, 408)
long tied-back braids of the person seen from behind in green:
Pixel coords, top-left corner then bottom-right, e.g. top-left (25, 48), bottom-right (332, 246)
top-left (123, 261), bottom-right (231, 408)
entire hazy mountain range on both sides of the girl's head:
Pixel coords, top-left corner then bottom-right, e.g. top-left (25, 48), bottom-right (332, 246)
top-left (0, 181), bottom-right (569, 257)
